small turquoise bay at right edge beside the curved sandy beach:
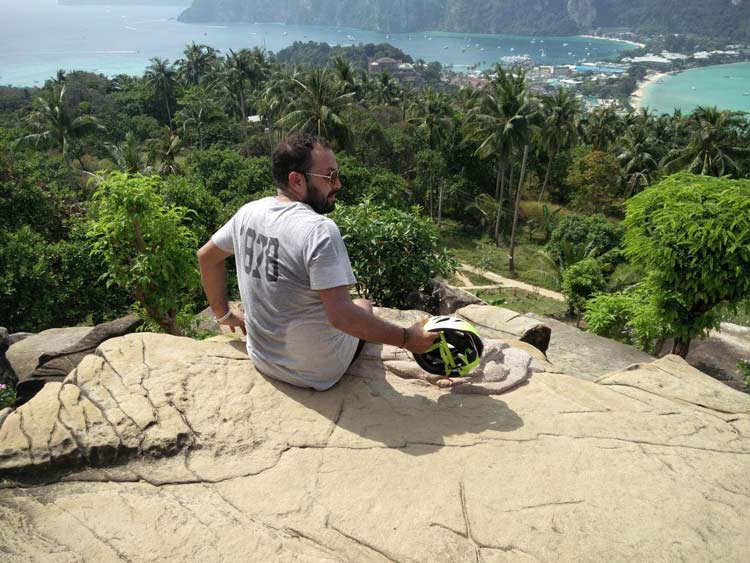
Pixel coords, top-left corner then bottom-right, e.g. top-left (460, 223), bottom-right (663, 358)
top-left (640, 63), bottom-right (750, 113)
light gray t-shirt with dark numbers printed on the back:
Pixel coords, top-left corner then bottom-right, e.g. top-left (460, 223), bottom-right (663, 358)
top-left (211, 197), bottom-right (358, 391)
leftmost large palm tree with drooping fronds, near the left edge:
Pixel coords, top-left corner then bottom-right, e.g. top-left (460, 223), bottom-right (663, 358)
top-left (16, 85), bottom-right (104, 168)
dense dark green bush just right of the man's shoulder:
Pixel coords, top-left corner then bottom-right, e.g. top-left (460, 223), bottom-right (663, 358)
top-left (333, 199), bottom-right (457, 308)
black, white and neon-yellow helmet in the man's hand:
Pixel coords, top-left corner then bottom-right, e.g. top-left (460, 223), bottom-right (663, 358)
top-left (414, 317), bottom-right (484, 377)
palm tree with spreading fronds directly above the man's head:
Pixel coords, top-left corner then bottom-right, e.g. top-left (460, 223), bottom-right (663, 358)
top-left (276, 67), bottom-right (354, 147)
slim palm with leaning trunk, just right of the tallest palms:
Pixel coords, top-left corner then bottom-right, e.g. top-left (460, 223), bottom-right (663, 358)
top-left (539, 88), bottom-right (580, 202)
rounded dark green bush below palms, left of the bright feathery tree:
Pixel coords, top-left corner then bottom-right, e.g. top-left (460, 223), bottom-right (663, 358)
top-left (546, 215), bottom-right (622, 267)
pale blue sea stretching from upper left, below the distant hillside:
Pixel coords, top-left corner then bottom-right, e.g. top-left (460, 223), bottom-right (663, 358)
top-left (0, 0), bottom-right (630, 86)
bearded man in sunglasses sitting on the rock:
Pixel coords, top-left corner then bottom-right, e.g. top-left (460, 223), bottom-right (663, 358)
top-left (198, 133), bottom-right (436, 391)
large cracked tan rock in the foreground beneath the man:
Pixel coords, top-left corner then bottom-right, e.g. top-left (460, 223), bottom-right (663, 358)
top-left (0, 308), bottom-right (750, 563)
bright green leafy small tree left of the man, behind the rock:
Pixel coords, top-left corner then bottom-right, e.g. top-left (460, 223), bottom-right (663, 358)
top-left (88, 172), bottom-right (199, 334)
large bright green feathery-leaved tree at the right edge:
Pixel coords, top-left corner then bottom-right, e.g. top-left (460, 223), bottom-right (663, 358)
top-left (625, 173), bottom-right (750, 352)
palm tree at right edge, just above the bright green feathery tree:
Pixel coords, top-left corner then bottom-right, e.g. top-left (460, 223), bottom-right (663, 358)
top-left (662, 106), bottom-right (750, 176)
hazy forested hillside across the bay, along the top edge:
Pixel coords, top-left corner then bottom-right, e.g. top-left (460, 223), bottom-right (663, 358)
top-left (180, 0), bottom-right (750, 39)
